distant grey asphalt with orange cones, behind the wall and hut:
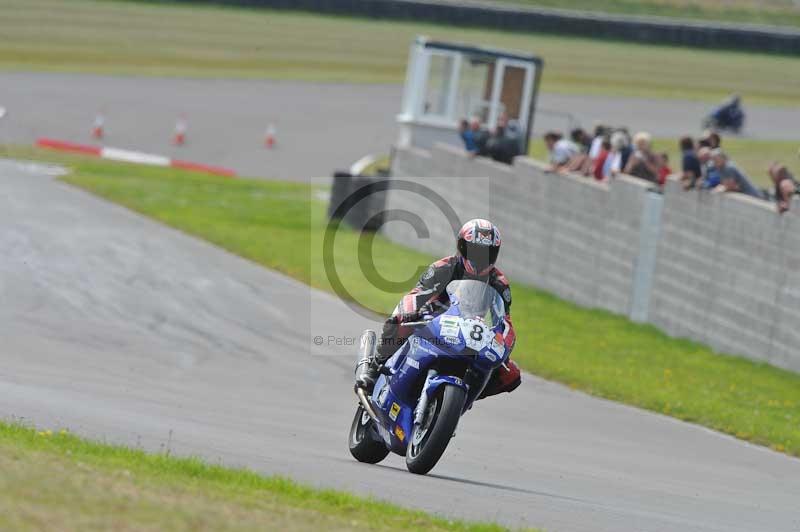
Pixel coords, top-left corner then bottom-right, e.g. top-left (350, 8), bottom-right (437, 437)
top-left (0, 73), bottom-right (800, 179)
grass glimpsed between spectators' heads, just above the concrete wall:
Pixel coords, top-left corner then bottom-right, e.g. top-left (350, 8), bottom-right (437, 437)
top-left (529, 137), bottom-right (800, 188)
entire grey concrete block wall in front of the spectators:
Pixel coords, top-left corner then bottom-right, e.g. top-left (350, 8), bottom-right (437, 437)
top-left (384, 144), bottom-right (800, 371)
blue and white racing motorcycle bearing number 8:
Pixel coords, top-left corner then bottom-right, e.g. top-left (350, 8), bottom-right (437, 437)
top-left (349, 280), bottom-right (511, 475)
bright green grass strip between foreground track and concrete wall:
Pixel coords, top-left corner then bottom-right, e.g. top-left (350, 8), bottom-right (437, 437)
top-left (7, 144), bottom-right (800, 456)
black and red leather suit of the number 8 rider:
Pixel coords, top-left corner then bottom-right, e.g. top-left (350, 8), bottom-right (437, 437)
top-left (378, 255), bottom-right (521, 397)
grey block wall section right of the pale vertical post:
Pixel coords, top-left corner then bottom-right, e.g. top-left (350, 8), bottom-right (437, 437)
top-left (650, 179), bottom-right (800, 370)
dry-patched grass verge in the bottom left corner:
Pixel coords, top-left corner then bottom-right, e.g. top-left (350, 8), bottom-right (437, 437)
top-left (0, 422), bottom-right (520, 532)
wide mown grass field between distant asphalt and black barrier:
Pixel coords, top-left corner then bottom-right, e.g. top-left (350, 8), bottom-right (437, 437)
top-left (0, 0), bottom-right (800, 105)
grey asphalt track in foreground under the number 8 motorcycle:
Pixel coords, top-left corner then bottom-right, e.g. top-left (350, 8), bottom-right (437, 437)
top-left (0, 160), bottom-right (800, 532)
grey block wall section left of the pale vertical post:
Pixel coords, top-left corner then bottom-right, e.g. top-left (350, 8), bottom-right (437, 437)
top-left (384, 144), bottom-right (648, 314)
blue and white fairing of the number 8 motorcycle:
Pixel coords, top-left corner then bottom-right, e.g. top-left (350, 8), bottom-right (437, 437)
top-left (372, 280), bottom-right (510, 454)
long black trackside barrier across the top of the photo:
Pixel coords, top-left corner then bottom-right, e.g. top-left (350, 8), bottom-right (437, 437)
top-left (155, 0), bottom-right (800, 55)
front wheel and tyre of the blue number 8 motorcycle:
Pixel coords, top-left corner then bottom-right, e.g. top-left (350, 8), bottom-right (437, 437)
top-left (406, 384), bottom-right (467, 475)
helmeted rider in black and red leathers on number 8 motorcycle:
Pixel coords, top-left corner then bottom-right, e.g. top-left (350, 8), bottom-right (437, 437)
top-left (356, 218), bottom-right (521, 398)
